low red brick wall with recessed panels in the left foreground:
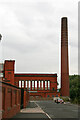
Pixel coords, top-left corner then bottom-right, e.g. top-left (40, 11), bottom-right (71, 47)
top-left (2, 82), bottom-right (21, 118)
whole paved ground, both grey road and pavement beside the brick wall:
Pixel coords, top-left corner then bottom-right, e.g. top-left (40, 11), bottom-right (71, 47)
top-left (10, 100), bottom-right (78, 120)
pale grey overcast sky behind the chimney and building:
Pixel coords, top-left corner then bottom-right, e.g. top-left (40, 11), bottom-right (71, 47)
top-left (0, 0), bottom-right (78, 88)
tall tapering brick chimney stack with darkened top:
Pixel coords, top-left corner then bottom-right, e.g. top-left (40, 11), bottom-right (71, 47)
top-left (61, 17), bottom-right (69, 96)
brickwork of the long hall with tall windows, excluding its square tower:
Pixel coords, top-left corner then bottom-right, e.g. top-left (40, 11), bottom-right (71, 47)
top-left (14, 74), bottom-right (59, 97)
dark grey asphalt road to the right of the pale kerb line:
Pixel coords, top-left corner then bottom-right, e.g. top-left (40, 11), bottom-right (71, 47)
top-left (36, 100), bottom-right (78, 118)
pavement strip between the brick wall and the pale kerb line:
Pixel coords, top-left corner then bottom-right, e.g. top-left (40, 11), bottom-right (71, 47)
top-left (10, 101), bottom-right (50, 120)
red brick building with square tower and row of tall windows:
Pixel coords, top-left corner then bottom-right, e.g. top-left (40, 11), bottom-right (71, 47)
top-left (3, 60), bottom-right (60, 97)
